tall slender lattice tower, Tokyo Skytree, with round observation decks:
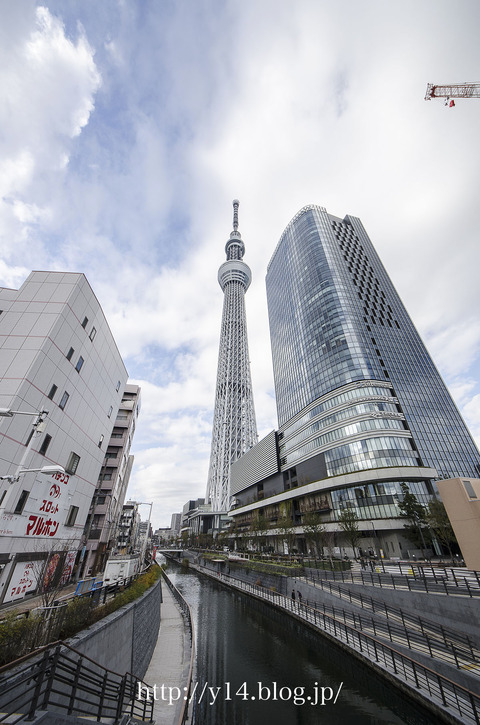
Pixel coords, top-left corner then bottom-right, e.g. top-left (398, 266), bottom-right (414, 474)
top-left (206, 199), bottom-right (258, 513)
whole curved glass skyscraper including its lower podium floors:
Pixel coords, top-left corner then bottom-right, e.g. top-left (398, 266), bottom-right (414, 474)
top-left (230, 206), bottom-right (480, 557)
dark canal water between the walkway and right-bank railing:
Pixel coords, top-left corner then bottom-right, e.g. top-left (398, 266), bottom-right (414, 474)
top-left (168, 565), bottom-right (438, 725)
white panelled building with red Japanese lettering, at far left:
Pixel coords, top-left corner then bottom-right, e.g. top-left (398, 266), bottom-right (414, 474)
top-left (0, 272), bottom-right (127, 604)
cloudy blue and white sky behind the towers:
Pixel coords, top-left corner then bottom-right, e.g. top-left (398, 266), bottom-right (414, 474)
top-left (0, 0), bottom-right (480, 526)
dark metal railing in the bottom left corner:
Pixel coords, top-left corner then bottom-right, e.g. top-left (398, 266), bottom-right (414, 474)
top-left (0, 642), bottom-right (153, 725)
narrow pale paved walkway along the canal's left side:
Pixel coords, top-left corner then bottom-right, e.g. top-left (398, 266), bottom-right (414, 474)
top-left (143, 582), bottom-right (190, 725)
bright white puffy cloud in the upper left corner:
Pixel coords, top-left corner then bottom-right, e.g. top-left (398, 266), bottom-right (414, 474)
top-left (0, 3), bottom-right (100, 259)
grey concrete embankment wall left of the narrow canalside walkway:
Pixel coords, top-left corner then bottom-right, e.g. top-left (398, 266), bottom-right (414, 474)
top-left (67, 579), bottom-right (162, 679)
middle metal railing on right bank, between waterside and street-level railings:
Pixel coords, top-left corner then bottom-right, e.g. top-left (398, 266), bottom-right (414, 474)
top-left (305, 574), bottom-right (480, 667)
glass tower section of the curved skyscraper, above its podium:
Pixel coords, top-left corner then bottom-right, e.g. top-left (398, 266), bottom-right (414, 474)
top-left (266, 206), bottom-right (480, 478)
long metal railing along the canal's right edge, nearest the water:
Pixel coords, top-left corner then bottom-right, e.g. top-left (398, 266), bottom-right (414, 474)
top-left (191, 565), bottom-right (480, 725)
